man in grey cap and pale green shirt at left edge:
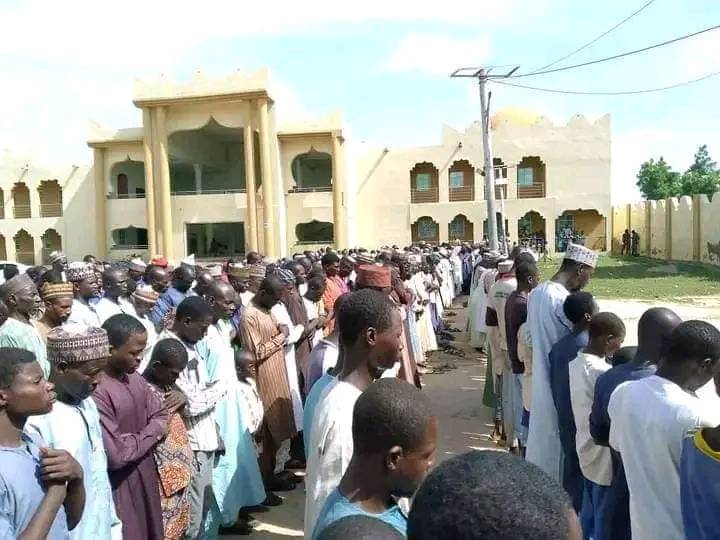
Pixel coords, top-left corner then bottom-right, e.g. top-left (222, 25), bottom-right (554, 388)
top-left (0, 274), bottom-right (50, 377)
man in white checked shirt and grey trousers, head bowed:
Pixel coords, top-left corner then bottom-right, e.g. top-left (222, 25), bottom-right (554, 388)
top-left (159, 296), bottom-right (225, 539)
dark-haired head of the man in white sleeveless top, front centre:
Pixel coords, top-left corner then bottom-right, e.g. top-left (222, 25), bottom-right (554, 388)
top-left (337, 289), bottom-right (402, 372)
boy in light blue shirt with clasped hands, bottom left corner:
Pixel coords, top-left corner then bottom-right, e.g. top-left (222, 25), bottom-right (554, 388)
top-left (0, 347), bottom-right (85, 540)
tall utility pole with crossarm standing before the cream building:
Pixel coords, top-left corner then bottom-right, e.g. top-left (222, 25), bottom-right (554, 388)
top-left (450, 66), bottom-right (520, 250)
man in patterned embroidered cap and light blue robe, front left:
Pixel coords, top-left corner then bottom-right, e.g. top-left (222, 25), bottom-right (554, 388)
top-left (26, 325), bottom-right (122, 540)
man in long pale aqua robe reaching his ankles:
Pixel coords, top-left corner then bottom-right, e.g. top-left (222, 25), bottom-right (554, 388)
top-left (197, 281), bottom-right (265, 537)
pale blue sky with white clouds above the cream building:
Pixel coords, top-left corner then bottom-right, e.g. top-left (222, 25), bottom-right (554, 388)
top-left (0, 0), bottom-right (720, 203)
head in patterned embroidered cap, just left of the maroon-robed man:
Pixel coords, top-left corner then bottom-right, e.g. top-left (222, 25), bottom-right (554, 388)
top-left (47, 325), bottom-right (110, 403)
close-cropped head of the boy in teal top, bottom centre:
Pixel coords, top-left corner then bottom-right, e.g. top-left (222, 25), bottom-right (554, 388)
top-left (352, 378), bottom-right (438, 497)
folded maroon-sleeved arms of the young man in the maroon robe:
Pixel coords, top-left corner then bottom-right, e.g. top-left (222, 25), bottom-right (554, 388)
top-left (93, 387), bottom-right (168, 471)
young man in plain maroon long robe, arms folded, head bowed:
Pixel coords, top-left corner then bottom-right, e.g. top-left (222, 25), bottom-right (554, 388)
top-left (93, 313), bottom-right (169, 540)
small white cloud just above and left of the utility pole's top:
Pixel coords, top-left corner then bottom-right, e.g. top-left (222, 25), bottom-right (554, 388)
top-left (387, 33), bottom-right (490, 75)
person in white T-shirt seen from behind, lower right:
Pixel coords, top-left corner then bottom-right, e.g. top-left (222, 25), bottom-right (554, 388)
top-left (608, 321), bottom-right (720, 540)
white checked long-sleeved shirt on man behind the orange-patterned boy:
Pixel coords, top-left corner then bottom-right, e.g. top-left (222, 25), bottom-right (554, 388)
top-left (158, 330), bottom-right (225, 452)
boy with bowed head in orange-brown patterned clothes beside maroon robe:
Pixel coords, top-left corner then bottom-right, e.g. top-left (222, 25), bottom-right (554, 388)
top-left (143, 339), bottom-right (194, 539)
